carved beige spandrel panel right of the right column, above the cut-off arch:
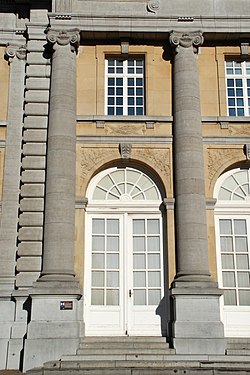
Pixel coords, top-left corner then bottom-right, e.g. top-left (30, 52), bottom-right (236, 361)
top-left (207, 148), bottom-right (244, 187)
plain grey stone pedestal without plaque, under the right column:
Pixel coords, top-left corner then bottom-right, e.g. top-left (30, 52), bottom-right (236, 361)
top-left (170, 281), bottom-right (226, 355)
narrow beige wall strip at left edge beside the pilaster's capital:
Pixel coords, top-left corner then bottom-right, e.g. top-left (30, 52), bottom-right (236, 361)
top-left (0, 47), bottom-right (9, 121)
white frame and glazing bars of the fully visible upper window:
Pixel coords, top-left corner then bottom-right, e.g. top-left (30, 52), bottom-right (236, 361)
top-left (105, 56), bottom-right (145, 116)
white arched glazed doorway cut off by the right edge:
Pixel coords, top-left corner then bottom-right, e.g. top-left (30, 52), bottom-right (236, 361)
top-left (215, 168), bottom-right (250, 337)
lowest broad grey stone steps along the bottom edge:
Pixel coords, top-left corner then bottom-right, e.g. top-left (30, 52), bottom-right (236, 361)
top-left (27, 356), bottom-right (250, 375)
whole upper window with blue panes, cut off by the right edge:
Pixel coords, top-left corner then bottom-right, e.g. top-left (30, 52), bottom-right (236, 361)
top-left (226, 61), bottom-right (250, 116)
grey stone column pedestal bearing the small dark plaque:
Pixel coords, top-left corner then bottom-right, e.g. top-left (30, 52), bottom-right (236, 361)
top-left (23, 294), bottom-right (83, 371)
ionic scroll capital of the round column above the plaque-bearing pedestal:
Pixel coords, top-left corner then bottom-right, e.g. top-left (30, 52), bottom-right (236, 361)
top-left (47, 29), bottom-right (80, 50)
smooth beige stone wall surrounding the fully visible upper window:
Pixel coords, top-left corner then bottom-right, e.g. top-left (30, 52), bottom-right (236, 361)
top-left (77, 45), bottom-right (172, 116)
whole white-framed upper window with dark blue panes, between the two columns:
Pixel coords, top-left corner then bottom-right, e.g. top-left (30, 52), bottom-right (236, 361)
top-left (105, 58), bottom-right (145, 116)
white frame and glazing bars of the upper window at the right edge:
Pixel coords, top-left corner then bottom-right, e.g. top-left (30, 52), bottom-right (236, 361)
top-left (225, 59), bottom-right (250, 116)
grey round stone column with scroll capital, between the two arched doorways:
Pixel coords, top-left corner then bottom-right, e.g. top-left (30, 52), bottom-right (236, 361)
top-left (170, 33), bottom-right (209, 280)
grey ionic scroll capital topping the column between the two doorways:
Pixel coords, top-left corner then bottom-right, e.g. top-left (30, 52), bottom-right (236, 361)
top-left (169, 31), bottom-right (204, 53)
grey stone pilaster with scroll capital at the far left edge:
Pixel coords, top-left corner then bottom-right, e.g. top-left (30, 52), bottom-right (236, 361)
top-left (0, 45), bottom-right (26, 296)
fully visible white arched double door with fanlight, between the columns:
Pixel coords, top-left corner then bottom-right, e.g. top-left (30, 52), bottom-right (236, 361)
top-left (84, 167), bottom-right (164, 335)
